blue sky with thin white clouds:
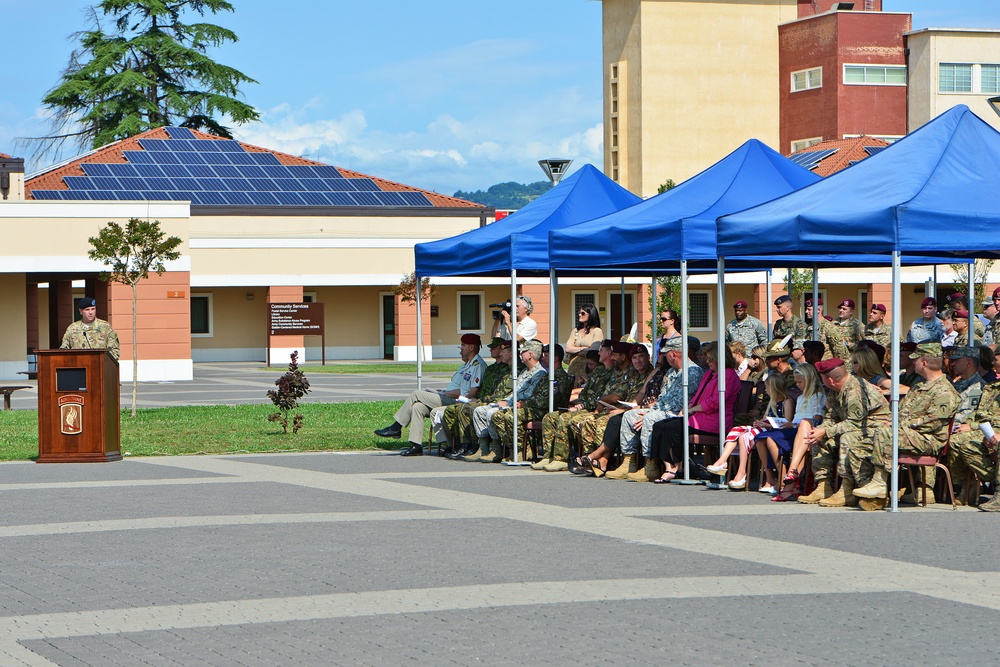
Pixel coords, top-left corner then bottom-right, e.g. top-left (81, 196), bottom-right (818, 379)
top-left (0, 0), bottom-right (1000, 194)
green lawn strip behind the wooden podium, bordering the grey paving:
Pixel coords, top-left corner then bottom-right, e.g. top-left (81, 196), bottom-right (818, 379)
top-left (0, 401), bottom-right (414, 461)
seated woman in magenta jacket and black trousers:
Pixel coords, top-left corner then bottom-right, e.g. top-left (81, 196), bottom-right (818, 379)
top-left (650, 345), bottom-right (740, 484)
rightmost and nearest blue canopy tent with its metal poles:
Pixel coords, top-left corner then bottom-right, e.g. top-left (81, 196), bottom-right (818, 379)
top-left (718, 105), bottom-right (1000, 511)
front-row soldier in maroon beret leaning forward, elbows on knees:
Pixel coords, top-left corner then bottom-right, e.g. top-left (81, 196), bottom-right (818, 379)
top-left (798, 357), bottom-right (892, 507)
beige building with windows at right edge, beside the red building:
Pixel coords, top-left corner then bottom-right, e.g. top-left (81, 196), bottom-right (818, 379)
top-left (905, 28), bottom-right (1000, 132)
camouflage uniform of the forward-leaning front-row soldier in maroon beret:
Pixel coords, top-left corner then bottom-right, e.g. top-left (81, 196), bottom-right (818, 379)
top-left (811, 375), bottom-right (892, 486)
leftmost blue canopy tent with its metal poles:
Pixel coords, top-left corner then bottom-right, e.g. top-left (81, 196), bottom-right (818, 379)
top-left (414, 164), bottom-right (642, 464)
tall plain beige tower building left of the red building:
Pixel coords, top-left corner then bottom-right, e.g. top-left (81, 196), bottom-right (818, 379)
top-left (603, 0), bottom-right (798, 197)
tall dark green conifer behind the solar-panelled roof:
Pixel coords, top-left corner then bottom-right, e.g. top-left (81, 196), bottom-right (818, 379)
top-left (36, 0), bottom-right (259, 157)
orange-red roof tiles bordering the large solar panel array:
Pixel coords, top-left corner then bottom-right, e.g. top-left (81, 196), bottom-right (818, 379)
top-left (24, 127), bottom-right (483, 208)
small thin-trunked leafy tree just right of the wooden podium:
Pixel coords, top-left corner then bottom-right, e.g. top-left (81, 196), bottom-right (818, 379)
top-left (87, 218), bottom-right (181, 417)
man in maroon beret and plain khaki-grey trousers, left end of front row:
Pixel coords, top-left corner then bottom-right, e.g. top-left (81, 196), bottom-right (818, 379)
top-left (375, 334), bottom-right (486, 456)
